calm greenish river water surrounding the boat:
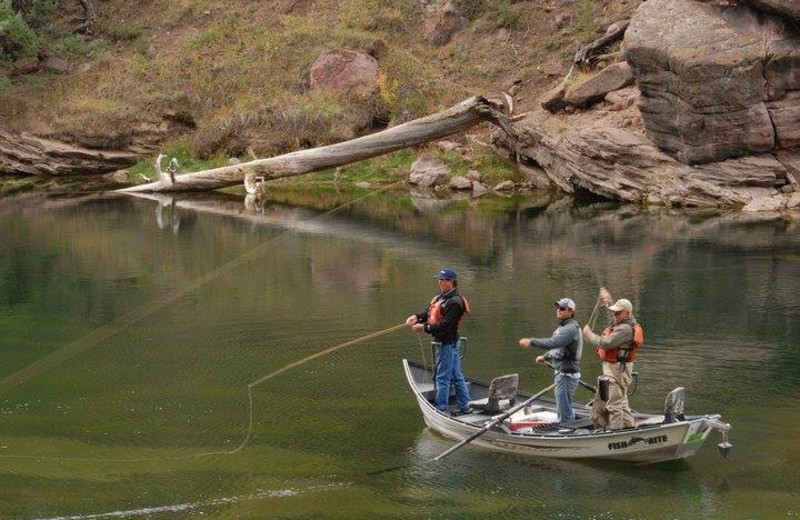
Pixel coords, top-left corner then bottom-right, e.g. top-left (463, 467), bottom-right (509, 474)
top-left (0, 193), bottom-right (800, 520)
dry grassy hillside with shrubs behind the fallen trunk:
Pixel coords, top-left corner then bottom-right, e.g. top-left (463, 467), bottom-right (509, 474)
top-left (0, 0), bottom-right (639, 169)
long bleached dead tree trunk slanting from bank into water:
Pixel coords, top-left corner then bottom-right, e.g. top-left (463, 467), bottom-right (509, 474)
top-left (119, 96), bottom-right (512, 192)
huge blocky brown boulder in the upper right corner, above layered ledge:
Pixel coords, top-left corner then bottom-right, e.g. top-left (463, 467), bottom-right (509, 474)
top-left (623, 0), bottom-right (800, 164)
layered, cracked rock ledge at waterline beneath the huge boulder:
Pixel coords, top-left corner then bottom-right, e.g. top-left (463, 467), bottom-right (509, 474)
top-left (502, 99), bottom-right (800, 210)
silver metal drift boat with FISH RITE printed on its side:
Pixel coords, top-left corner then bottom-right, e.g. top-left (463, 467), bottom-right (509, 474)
top-left (403, 359), bottom-right (731, 463)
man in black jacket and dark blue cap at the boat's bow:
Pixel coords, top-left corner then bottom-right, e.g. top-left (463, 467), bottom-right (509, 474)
top-left (406, 267), bottom-right (472, 413)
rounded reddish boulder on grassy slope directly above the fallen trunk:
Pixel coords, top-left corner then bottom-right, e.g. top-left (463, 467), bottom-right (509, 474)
top-left (309, 49), bottom-right (379, 97)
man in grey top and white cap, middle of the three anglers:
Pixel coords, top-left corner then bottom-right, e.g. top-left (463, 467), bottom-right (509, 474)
top-left (519, 298), bottom-right (583, 423)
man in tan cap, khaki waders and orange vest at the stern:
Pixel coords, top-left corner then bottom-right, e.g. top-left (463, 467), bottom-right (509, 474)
top-left (583, 288), bottom-right (644, 430)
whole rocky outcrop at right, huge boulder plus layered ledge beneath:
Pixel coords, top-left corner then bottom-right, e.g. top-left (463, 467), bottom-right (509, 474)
top-left (502, 0), bottom-right (800, 211)
